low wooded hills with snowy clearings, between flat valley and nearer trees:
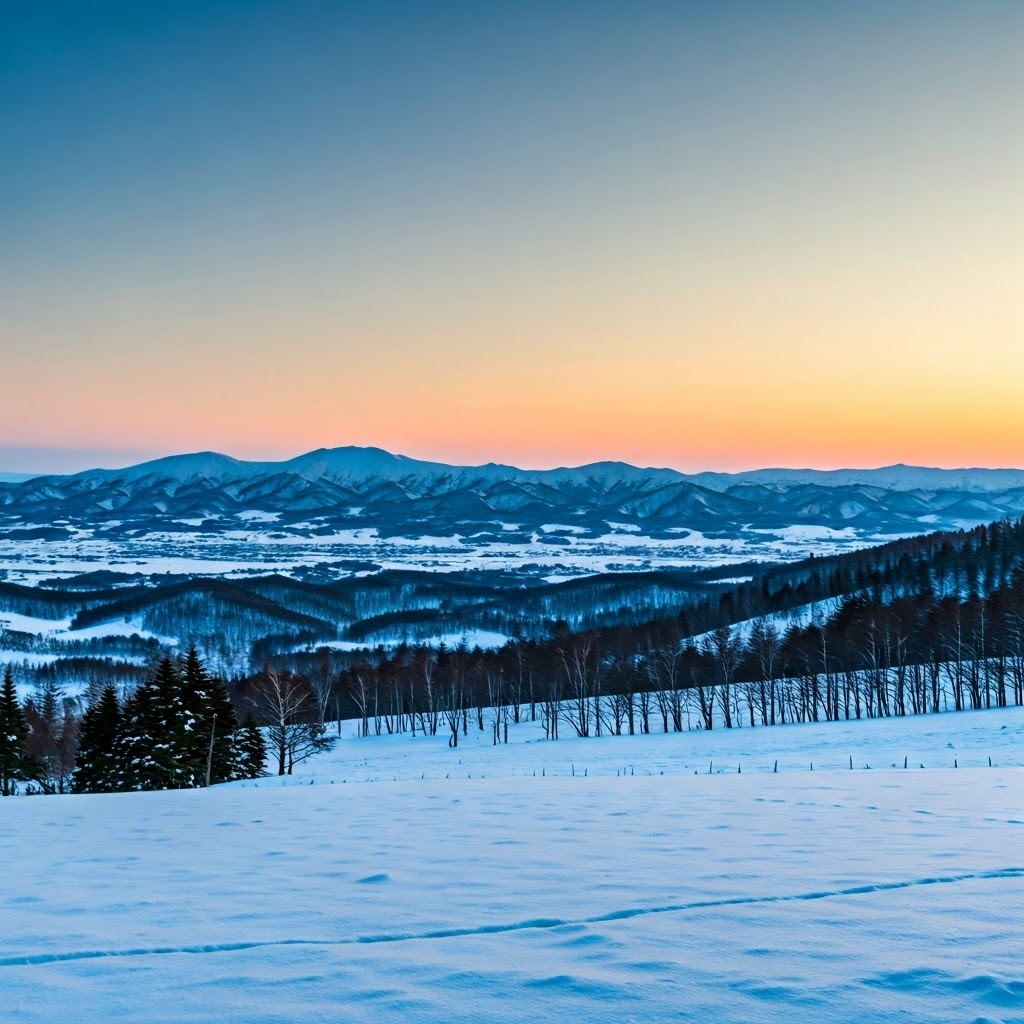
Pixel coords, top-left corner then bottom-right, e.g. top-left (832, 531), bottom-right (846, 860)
top-left (0, 565), bottom-right (744, 691)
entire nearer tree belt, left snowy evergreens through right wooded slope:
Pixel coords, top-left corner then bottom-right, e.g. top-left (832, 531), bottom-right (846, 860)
top-left (0, 520), bottom-right (1024, 795)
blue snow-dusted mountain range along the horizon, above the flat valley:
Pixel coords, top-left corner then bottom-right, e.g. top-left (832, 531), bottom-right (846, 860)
top-left (0, 447), bottom-right (1024, 538)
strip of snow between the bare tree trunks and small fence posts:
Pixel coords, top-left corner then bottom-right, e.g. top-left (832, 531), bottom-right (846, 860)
top-left (241, 698), bottom-right (1024, 787)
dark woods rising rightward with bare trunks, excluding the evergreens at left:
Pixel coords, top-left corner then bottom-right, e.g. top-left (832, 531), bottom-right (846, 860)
top-left (279, 522), bottom-right (1024, 746)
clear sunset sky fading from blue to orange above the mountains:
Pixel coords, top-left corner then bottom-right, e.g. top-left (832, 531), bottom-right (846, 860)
top-left (0, 0), bottom-right (1024, 472)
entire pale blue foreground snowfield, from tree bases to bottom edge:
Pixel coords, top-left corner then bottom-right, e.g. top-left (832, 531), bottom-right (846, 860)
top-left (0, 709), bottom-right (1024, 1024)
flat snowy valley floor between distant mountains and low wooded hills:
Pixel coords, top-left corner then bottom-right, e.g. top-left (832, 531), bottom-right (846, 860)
top-left (0, 520), bottom-right (912, 584)
